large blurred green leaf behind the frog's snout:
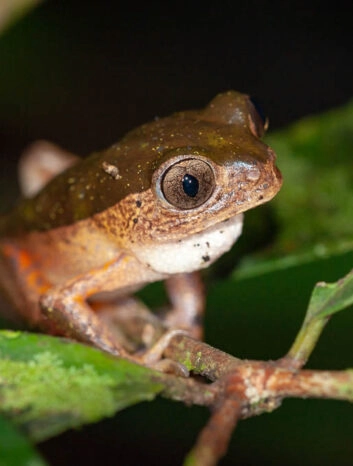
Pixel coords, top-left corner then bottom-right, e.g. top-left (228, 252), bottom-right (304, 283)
top-left (234, 101), bottom-right (353, 278)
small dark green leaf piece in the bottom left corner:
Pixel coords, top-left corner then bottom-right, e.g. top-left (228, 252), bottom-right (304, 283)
top-left (0, 416), bottom-right (46, 466)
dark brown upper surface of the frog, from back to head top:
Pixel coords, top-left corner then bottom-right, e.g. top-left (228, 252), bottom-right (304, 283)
top-left (0, 91), bottom-right (277, 236)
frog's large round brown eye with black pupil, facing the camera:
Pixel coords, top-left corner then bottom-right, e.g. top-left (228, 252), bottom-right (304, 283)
top-left (161, 159), bottom-right (215, 210)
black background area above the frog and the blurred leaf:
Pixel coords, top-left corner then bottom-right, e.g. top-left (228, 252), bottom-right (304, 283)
top-left (0, 0), bottom-right (353, 169)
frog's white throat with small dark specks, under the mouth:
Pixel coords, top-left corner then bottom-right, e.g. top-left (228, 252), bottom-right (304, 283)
top-left (134, 214), bottom-right (243, 274)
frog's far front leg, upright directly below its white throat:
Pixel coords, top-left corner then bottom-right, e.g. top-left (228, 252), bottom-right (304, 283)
top-left (165, 272), bottom-right (205, 340)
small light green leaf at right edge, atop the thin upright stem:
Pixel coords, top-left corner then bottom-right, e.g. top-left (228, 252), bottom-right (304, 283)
top-left (306, 271), bottom-right (353, 320)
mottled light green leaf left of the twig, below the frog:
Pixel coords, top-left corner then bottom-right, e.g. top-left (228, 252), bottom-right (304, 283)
top-left (0, 331), bottom-right (164, 440)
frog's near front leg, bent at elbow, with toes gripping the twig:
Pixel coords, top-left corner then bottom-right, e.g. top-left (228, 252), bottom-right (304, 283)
top-left (40, 255), bottom-right (187, 376)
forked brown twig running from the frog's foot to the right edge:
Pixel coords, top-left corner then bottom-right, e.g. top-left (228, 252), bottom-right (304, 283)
top-left (160, 335), bottom-right (353, 466)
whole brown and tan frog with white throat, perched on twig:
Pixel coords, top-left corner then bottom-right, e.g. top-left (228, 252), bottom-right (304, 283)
top-left (0, 91), bottom-right (282, 364)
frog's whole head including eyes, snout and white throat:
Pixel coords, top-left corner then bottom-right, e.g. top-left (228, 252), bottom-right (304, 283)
top-left (110, 91), bottom-right (282, 272)
